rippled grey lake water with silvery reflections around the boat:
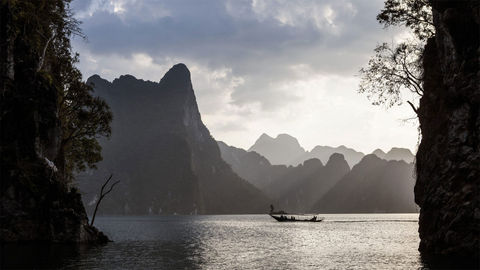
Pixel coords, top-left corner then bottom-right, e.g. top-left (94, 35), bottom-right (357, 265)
top-left (2, 214), bottom-right (432, 269)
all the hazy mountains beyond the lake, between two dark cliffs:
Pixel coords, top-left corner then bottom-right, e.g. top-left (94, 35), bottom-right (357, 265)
top-left (79, 64), bottom-right (416, 215)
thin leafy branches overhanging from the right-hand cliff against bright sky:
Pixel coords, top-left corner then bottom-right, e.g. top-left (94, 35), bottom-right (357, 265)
top-left (358, 0), bottom-right (435, 113)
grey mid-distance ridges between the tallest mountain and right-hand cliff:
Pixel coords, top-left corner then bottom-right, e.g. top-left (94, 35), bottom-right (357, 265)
top-left (218, 140), bottom-right (417, 213)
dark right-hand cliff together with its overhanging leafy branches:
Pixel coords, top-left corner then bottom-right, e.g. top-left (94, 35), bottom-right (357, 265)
top-left (360, 0), bottom-right (480, 266)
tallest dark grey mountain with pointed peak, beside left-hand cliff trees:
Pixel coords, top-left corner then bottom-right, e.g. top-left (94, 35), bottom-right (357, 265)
top-left (80, 64), bottom-right (269, 214)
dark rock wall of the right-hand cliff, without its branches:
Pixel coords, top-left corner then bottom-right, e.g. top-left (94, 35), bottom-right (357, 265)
top-left (415, 0), bottom-right (480, 258)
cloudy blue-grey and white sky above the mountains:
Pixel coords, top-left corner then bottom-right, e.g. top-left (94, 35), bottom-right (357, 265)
top-left (72, 0), bottom-right (418, 153)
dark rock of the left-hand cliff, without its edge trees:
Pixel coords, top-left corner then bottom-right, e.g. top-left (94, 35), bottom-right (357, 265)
top-left (0, 1), bottom-right (108, 243)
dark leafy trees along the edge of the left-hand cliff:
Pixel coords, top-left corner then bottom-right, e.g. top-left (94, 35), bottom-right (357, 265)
top-left (37, 0), bottom-right (112, 181)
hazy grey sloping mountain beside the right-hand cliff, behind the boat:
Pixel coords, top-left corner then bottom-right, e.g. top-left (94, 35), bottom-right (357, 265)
top-left (312, 154), bottom-right (417, 213)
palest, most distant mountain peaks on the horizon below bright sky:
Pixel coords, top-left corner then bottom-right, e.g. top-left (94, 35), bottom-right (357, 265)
top-left (248, 133), bottom-right (415, 167)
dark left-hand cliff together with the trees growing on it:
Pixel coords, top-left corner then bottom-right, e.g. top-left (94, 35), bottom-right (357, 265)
top-left (0, 0), bottom-right (112, 242)
